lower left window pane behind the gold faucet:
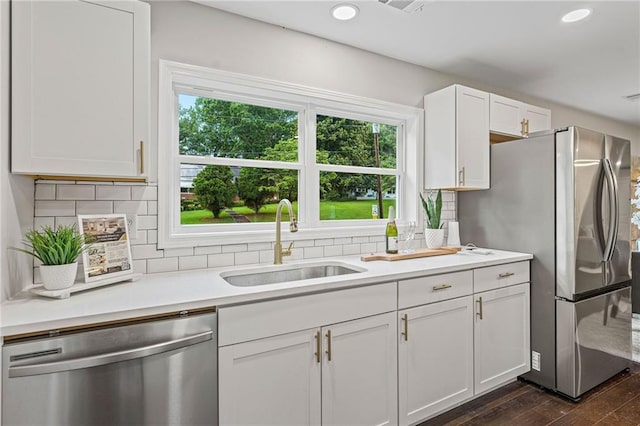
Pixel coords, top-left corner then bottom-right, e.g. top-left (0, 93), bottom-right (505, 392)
top-left (180, 164), bottom-right (298, 225)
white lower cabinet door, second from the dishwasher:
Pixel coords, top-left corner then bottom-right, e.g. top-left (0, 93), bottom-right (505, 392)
top-left (322, 312), bottom-right (398, 426)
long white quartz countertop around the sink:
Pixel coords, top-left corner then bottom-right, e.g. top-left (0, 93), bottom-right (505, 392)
top-left (0, 250), bottom-right (533, 336)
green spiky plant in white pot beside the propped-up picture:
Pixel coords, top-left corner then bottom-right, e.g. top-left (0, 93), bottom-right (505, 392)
top-left (16, 225), bottom-right (89, 290)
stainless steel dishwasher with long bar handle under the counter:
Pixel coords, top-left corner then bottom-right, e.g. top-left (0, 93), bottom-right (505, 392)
top-left (2, 308), bottom-right (218, 426)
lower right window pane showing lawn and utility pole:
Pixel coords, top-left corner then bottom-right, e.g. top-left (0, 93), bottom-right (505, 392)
top-left (320, 172), bottom-right (396, 220)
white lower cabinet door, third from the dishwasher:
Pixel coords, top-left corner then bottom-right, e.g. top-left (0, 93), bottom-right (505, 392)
top-left (398, 296), bottom-right (473, 425)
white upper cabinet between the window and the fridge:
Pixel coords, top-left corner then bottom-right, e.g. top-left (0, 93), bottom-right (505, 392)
top-left (424, 84), bottom-right (489, 189)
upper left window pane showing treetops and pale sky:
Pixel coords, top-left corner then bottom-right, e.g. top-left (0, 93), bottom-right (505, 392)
top-left (178, 94), bottom-right (298, 162)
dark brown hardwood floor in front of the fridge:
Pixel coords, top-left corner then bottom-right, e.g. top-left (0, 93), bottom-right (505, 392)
top-left (420, 363), bottom-right (640, 426)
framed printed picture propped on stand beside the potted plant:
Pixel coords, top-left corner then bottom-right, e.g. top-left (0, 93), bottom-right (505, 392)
top-left (78, 214), bottom-right (133, 283)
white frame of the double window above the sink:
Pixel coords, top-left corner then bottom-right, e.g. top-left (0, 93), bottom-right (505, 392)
top-left (158, 60), bottom-right (424, 248)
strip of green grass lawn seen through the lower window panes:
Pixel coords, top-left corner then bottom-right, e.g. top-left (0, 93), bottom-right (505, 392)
top-left (180, 200), bottom-right (395, 225)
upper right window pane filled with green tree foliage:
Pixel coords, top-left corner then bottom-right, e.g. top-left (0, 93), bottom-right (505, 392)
top-left (316, 115), bottom-right (398, 169)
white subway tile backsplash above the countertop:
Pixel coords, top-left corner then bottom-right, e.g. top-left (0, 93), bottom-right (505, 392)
top-left (33, 181), bottom-right (456, 276)
